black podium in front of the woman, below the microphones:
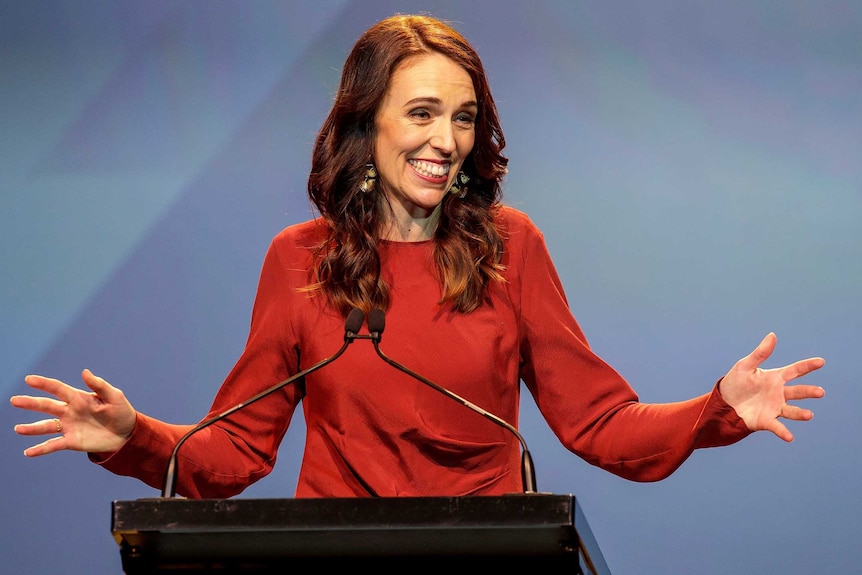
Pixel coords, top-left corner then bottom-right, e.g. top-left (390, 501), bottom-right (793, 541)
top-left (111, 493), bottom-right (610, 575)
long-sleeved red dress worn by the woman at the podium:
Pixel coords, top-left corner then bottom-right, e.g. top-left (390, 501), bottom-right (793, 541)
top-left (98, 207), bottom-right (749, 498)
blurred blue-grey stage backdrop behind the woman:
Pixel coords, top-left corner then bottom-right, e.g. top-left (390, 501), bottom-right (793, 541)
top-left (0, 0), bottom-right (862, 575)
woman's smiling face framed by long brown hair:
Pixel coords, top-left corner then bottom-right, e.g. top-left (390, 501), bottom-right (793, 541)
top-left (374, 53), bottom-right (478, 223)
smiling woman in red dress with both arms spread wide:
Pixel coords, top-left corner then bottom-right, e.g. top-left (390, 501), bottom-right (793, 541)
top-left (12, 16), bottom-right (824, 498)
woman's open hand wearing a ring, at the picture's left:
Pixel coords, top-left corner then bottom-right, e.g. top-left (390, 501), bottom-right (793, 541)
top-left (11, 369), bottom-right (137, 457)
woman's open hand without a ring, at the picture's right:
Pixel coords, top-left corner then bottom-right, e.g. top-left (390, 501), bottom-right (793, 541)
top-left (719, 333), bottom-right (826, 441)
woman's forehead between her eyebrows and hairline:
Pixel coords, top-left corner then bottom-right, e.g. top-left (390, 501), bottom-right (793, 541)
top-left (386, 52), bottom-right (476, 101)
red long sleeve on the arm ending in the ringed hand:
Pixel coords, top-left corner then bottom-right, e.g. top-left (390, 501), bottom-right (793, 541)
top-left (90, 226), bottom-right (314, 498)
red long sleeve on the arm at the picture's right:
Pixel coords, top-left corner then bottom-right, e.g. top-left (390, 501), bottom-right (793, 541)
top-left (511, 212), bottom-right (750, 481)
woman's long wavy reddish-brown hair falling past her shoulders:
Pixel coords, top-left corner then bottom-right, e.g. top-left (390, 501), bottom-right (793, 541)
top-left (307, 15), bottom-right (508, 314)
